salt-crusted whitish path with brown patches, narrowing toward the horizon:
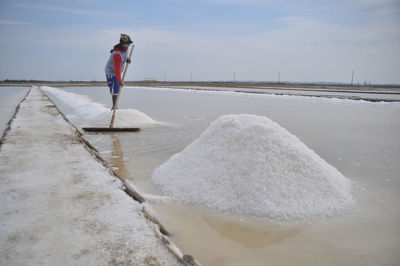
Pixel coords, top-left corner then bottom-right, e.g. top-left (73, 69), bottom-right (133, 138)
top-left (0, 87), bottom-right (179, 265)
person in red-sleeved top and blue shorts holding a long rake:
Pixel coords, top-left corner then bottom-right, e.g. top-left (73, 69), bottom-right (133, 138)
top-left (105, 34), bottom-right (133, 110)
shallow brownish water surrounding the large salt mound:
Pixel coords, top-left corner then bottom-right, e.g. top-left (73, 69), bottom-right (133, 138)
top-left (43, 87), bottom-right (400, 265)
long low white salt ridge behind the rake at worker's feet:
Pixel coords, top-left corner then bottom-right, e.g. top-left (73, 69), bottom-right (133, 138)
top-left (41, 86), bottom-right (159, 127)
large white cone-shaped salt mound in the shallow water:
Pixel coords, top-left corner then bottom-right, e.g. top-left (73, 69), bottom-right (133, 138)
top-left (153, 115), bottom-right (353, 219)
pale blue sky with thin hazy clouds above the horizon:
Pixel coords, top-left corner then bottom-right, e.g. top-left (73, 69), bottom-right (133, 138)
top-left (0, 0), bottom-right (400, 83)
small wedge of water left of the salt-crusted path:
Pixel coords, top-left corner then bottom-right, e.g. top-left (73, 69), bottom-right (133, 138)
top-left (0, 87), bottom-right (29, 136)
